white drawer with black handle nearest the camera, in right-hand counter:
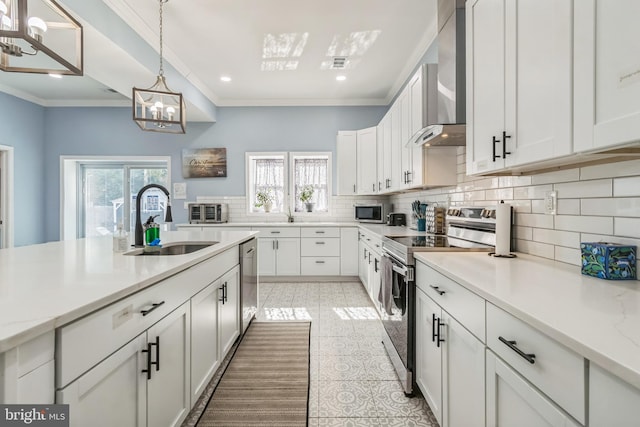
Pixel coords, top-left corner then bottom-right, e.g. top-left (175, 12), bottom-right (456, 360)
top-left (487, 303), bottom-right (586, 424)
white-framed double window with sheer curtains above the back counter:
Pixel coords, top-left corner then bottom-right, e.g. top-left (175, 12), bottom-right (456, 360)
top-left (246, 152), bottom-right (331, 214)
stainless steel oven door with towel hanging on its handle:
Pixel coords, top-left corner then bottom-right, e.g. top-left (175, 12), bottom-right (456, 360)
top-left (381, 253), bottom-right (415, 395)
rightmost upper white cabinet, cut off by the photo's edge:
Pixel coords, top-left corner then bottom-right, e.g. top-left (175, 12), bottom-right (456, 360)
top-left (574, 0), bottom-right (640, 151)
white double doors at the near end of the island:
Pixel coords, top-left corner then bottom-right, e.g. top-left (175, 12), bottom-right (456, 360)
top-left (57, 302), bottom-right (191, 427)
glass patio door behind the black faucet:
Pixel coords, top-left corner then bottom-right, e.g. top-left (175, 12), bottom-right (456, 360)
top-left (78, 162), bottom-right (169, 238)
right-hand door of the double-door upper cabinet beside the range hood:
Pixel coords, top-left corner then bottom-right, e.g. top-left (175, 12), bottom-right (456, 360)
top-left (502, 0), bottom-right (572, 168)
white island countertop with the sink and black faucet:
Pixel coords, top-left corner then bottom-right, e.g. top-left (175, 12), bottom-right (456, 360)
top-left (0, 230), bottom-right (257, 353)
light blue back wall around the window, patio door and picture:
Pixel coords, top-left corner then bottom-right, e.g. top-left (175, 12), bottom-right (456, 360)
top-left (44, 106), bottom-right (387, 241)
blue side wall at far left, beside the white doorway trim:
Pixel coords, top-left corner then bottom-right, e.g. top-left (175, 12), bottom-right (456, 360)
top-left (0, 93), bottom-right (45, 246)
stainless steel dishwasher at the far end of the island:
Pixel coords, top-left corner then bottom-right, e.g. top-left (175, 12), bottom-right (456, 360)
top-left (240, 239), bottom-right (258, 334)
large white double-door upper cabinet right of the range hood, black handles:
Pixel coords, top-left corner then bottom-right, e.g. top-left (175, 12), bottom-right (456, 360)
top-left (466, 0), bottom-right (573, 174)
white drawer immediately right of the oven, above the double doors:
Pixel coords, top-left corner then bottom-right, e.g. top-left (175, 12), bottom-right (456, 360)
top-left (416, 262), bottom-right (485, 342)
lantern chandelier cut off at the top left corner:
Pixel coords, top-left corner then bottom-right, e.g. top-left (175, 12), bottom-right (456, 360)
top-left (0, 0), bottom-right (83, 76)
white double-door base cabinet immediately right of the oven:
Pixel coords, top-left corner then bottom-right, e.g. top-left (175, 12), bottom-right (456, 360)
top-left (416, 289), bottom-right (485, 427)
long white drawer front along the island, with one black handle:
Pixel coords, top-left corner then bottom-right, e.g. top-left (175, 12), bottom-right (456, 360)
top-left (56, 247), bottom-right (239, 388)
